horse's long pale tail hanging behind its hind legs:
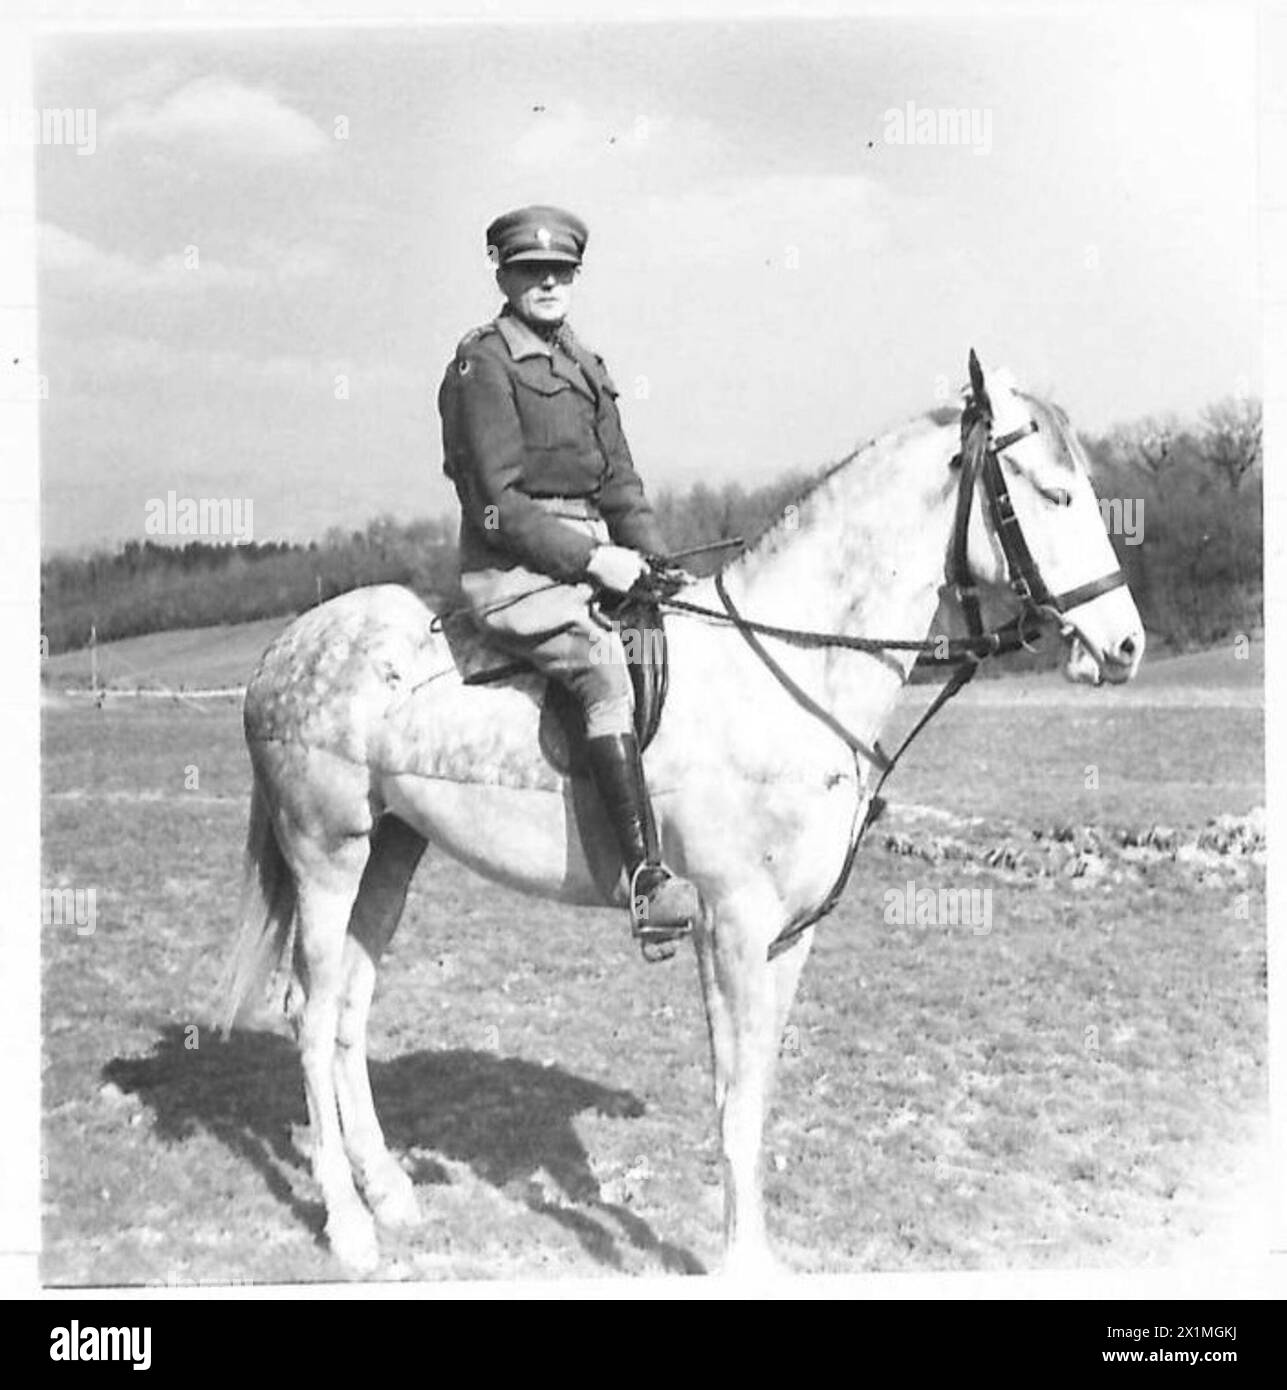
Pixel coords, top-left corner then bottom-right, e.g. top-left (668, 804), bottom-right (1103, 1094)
top-left (220, 773), bottom-right (299, 1037)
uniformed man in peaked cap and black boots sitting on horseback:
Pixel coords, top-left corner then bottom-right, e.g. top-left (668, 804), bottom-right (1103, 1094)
top-left (438, 207), bottom-right (698, 941)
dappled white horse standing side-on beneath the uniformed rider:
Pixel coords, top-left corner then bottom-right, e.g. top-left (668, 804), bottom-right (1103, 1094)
top-left (227, 357), bottom-right (1144, 1272)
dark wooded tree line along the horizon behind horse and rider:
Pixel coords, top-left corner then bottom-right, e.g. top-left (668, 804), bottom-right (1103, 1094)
top-left (40, 399), bottom-right (1263, 664)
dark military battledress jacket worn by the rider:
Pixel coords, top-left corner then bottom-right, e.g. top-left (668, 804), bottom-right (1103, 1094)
top-left (438, 309), bottom-right (664, 581)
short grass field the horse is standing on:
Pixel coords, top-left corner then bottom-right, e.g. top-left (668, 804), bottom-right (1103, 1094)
top-left (43, 636), bottom-right (1268, 1283)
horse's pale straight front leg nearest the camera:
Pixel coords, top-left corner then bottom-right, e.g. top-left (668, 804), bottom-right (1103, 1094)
top-left (696, 888), bottom-right (781, 1276)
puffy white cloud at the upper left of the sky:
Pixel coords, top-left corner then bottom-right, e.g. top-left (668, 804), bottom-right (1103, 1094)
top-left (104, 76), bottom-right (332, 164)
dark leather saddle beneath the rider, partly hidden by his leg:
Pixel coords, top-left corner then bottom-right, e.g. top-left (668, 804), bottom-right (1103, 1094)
top-left (441, 592), bottom-right (670, 777)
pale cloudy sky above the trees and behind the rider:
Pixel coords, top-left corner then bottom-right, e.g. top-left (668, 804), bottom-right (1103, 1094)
top-left (36, 6), bottom-right (1261, 550)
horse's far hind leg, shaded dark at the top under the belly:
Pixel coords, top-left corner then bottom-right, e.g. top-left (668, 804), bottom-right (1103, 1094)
top-left (335, 816), bottom-right (425, 1229)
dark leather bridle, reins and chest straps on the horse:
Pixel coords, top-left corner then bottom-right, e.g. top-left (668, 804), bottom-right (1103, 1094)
top-left (660, 391), bottom-right (1126, 960)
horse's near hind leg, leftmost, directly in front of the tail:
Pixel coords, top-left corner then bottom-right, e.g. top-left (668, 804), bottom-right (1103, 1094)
top-left (284, 835), bottom-right (379, 1273)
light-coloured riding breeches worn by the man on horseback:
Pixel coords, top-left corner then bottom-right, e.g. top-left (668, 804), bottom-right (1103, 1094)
top-left (460, 499), bottom-right (634, 738)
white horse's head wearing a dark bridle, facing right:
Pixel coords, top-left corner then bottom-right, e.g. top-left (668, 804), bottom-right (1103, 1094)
top-left (935, 350), bottom-right (1144, 685)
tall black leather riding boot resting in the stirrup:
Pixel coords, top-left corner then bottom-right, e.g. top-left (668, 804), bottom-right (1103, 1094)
top-left (585, 734), bottom-right (699, 942)
